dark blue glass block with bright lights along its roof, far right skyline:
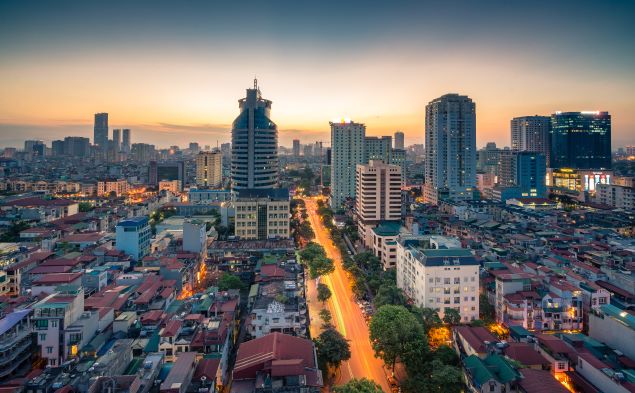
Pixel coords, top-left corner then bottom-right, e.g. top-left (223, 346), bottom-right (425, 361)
top-left (549, 112), bottom-right (611, 169)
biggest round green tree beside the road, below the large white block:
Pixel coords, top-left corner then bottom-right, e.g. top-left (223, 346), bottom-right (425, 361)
top-left (370, 305), bottom-right (428, 370)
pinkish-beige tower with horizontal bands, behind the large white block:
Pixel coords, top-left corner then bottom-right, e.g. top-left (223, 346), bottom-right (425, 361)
top-left (355, 160), bottom-right (401, 247)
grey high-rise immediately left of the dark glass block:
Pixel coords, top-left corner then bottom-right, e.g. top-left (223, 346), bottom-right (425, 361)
top-left (511, 115), bottom-right (551, 163)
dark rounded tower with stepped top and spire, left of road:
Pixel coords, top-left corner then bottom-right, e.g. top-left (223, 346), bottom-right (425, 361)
top-left (231, 80), bottom-right (279, 190)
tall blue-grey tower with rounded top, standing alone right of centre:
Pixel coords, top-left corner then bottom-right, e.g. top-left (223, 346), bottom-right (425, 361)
top-left (424, 94), bottom-right (476, 204)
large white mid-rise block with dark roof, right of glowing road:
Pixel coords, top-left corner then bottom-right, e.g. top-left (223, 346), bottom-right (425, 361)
top-left (397, 236), bottom-right (479, 322)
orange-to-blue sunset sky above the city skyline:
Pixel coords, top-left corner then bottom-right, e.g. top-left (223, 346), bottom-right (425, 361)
top-left (0, 0), bottom-right (635, 148)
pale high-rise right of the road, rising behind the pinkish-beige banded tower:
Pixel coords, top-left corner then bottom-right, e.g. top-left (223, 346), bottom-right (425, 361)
top-left (330, 119), bottom-right (366, 208)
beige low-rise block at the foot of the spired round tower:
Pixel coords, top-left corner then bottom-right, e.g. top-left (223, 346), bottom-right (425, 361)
top-left (234, 188), bottom-right (291, 240)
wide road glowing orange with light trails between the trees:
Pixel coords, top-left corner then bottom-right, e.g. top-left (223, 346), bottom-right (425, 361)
top-left (304, 198), bottom-right (390, 393)
